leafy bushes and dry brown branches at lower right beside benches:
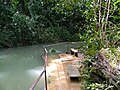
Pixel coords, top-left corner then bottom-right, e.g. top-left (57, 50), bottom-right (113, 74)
top-left (82, 48), bottom-right (120, 90)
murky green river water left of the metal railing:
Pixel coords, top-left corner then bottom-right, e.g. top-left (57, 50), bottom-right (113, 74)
top-left (0, 45), bottom-right (44, 90)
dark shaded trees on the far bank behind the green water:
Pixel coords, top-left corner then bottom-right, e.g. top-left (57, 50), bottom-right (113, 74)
top-left (0, 0), bottom-right (85, 47)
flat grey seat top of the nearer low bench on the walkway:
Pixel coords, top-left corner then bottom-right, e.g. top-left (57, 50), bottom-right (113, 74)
top-left (67, 65), bottom-right (80, 78)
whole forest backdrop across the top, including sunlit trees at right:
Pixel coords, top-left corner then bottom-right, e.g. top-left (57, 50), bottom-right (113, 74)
top-left (0, 0), bottom-right (120, 49)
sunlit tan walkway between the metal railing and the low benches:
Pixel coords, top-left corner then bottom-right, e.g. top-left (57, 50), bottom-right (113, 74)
top-left (47, 54), bottom-right (83, 90)
